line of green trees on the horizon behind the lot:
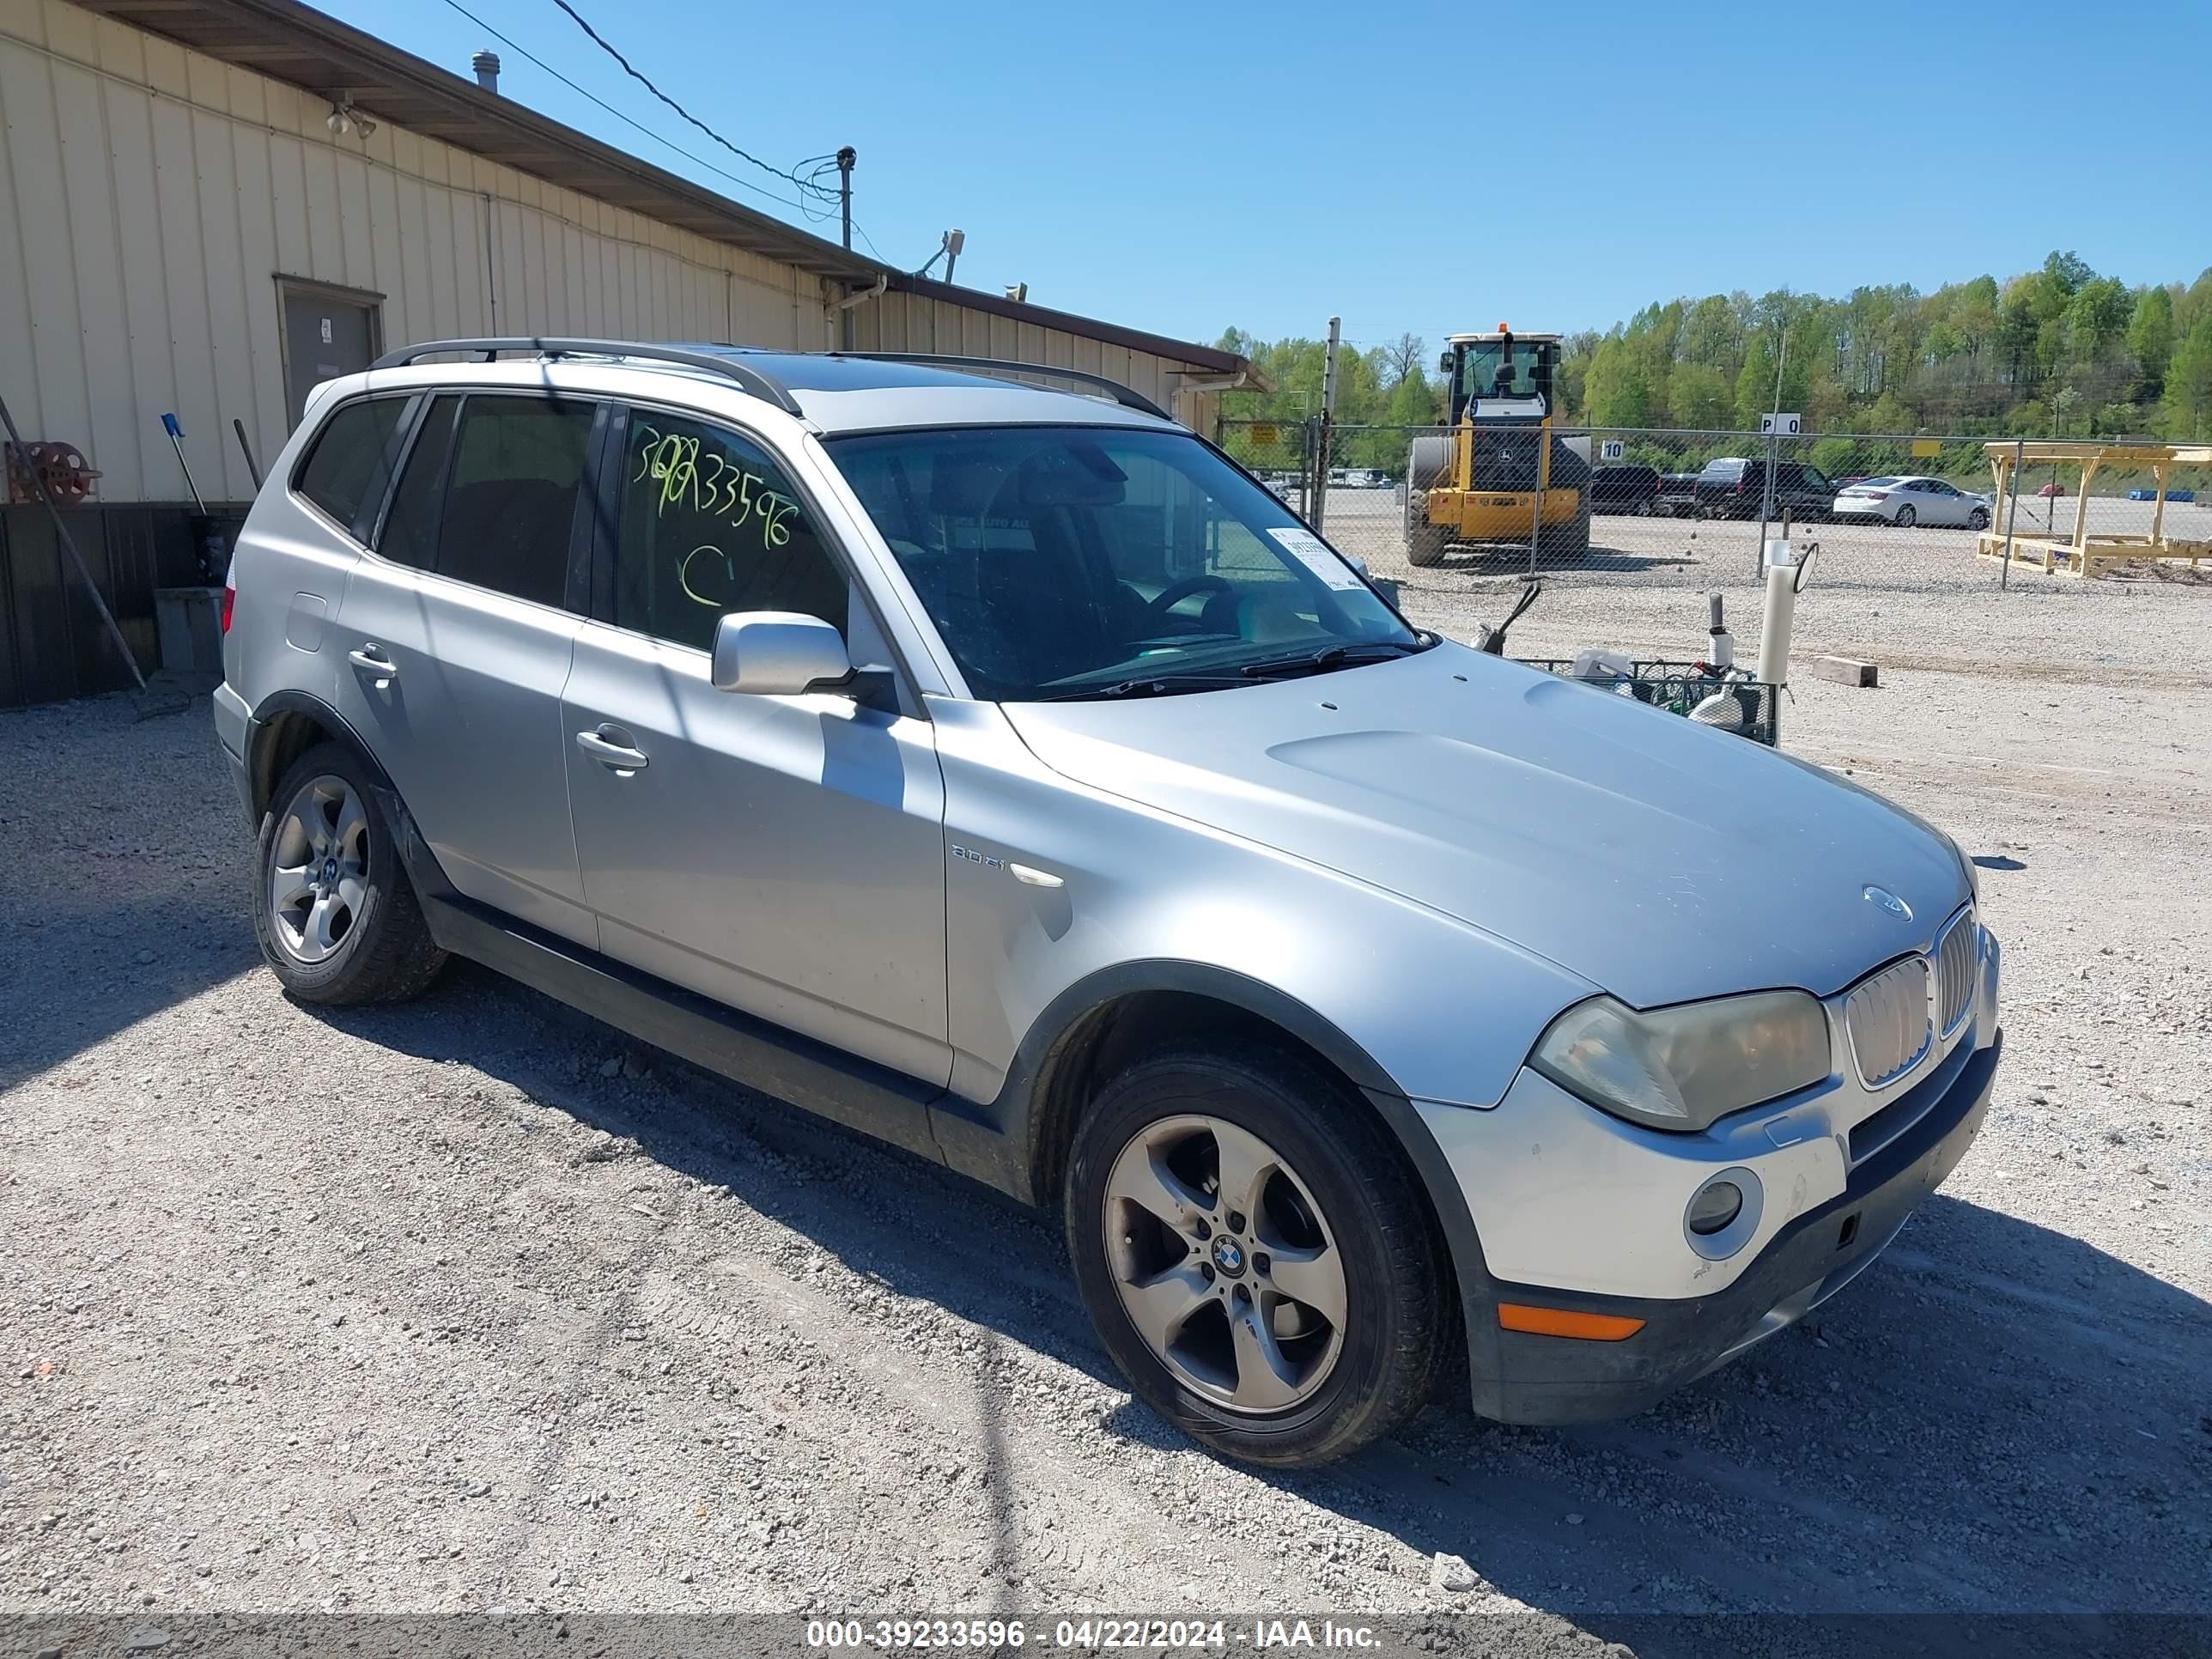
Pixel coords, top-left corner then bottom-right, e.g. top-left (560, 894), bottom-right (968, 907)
top-left (1221, 252), bottom-right (2212, 444)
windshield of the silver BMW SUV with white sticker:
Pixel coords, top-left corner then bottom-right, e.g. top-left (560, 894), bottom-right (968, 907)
top-left (825, 427), bottom-right (1425, 702)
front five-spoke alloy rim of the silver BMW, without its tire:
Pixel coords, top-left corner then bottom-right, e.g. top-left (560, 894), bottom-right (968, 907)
top-left (1106, 1115), bottom-right (1347, 1416)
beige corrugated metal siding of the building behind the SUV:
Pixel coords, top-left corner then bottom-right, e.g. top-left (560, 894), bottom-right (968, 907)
top-left (0, 0), bottom-right (1230, 502)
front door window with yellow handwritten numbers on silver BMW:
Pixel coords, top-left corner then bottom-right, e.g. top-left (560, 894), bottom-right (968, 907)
top-left (615, 410), bottom-right (852, 650)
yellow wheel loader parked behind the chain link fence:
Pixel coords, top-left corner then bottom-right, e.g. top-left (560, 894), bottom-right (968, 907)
top-left (1405, 323), bottom-right (1590, 566)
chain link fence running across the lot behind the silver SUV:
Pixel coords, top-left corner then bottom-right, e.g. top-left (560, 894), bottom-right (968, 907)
top-left (1217, 420), bottom-right (2212, 591)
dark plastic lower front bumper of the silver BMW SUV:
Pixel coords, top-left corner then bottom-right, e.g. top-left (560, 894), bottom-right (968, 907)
top-left (1467, 1033), bottom-right (2004, 1425)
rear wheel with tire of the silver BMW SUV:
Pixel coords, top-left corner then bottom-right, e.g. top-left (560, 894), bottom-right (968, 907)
top-left (254, 744), bottom-right (445, 1006)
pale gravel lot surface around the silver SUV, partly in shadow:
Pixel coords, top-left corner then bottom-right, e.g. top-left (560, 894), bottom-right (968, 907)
top-left (0, 528), bottom-right (2212, 1650)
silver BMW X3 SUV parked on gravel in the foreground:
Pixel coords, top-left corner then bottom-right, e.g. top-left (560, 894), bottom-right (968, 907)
top-left (215, 341), bottom-right (2000, 1464)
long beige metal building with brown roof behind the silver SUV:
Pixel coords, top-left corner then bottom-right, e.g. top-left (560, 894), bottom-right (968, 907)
top-left (0, 0), bottom-right (1249, 706)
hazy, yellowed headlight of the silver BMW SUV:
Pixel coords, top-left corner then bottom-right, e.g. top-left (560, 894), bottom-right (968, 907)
top-left (1528, 991), bottom-right (1829, 1130)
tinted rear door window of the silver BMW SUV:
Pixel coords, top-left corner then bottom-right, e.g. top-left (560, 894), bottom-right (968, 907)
top-left (376, 394), bottom-right (598, 606)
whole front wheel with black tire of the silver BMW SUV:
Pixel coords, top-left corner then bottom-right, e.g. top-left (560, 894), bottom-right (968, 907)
top-left (1066, 1044), bottom-right (1455, 1468)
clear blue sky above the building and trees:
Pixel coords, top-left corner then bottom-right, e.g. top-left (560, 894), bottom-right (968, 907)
top-left (340, 0), bottom-right (2212, 360)
